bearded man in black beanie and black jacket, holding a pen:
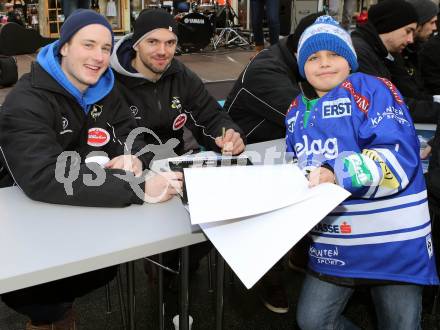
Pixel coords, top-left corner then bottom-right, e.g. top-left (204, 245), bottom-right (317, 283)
top-left (111, 9), bottom-right (244, 155)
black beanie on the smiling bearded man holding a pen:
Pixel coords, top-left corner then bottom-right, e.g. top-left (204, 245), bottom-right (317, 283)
top-left (132, 9), bottom-right (177, 47)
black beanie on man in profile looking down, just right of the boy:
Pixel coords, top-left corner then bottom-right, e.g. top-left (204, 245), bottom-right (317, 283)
top-left (368, 0), bottom-right (418, 34)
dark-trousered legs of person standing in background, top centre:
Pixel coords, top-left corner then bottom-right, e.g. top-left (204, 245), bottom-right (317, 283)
top-left (251, 0), bottom-right (280, 52)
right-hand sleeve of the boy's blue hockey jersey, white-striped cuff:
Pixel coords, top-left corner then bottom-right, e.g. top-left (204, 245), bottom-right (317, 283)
top-left (332, 78), bottom-right (421, 198)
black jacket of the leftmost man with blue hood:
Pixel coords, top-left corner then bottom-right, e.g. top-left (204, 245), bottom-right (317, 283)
top-left (0, 63), bottom-right (142, 207)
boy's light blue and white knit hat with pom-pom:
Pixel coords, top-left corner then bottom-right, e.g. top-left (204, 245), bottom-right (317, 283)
top-left (298, 15), bottom-right (358, 78)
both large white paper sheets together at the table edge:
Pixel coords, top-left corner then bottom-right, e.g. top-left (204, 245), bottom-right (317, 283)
top-left (184, 164), bottom-right (350, 289)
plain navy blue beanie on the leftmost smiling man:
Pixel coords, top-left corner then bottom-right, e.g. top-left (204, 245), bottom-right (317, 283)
top-left (57, 9), bottom-right (114, 53)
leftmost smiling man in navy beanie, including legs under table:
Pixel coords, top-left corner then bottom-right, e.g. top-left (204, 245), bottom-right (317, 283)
top-left (0, 10), bottom-right (181, 330)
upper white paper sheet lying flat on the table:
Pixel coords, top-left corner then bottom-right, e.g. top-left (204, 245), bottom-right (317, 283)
top-left (184, 164), bottom-right (309, 224)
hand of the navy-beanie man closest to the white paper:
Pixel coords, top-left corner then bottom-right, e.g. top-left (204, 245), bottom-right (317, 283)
top-left (144, 172), bottom-right (183, 203)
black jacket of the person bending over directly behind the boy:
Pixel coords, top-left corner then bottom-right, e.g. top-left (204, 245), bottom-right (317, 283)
top-left (224, 38), bottom-right (301, 143)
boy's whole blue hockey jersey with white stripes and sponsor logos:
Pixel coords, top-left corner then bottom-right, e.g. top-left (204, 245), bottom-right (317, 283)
top-left (286, 73), bottom-right (439, 284)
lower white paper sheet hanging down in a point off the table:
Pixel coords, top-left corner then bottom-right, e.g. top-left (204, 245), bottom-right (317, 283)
top-left (200, 183), bottom-right (350, 289)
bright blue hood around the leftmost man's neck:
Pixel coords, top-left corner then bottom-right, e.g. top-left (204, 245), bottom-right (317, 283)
top-left (37, 41), bottom-right (115, 114)
